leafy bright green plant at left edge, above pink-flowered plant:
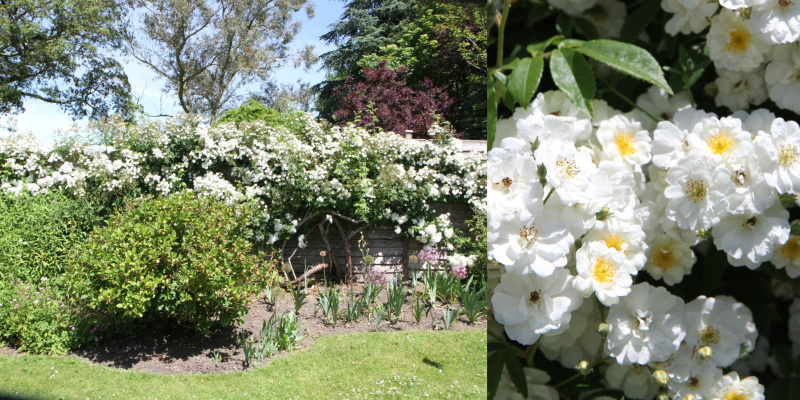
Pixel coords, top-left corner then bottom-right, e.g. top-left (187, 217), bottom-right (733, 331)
top-left (0, 191), bottom-right (101, 282)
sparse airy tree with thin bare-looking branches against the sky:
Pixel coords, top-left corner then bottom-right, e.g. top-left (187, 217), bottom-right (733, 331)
top-left (127, 0), bottom-right (313, 122)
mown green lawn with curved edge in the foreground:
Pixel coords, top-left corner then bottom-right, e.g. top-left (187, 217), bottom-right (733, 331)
top-left (0, 330), bottom-right (487, 400)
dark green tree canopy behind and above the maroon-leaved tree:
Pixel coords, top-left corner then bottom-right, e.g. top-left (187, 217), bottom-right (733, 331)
top-left (316, 0), bottom-right (486, 137)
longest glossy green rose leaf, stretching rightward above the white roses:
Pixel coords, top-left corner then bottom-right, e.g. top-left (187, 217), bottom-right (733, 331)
top-left (575, 39), bottom-right (672, 94)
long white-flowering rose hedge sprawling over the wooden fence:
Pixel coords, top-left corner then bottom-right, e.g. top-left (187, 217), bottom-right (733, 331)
top-left (0, 116), bottom-right (486, 272)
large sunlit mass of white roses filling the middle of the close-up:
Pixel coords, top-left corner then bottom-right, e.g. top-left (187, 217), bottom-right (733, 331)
top-left (488, 90), bottom-right (800, 399)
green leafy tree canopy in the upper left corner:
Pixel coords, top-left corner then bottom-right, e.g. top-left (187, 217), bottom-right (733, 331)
top-left (0, 0), bottom-right (133, 119)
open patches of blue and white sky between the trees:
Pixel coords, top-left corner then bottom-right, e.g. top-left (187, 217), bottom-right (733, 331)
top-left (0, 0), bottom-right (346, 143)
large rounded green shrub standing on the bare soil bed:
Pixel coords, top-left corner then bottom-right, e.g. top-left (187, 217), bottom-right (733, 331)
top-left (70, 191), bottom-right (266, 332)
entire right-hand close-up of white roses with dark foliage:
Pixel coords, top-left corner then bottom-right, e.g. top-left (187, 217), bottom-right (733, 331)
top-left (487, 0), bottom-right (800, 400)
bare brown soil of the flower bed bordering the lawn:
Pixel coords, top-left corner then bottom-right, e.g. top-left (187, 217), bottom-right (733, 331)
top-left (0, 284), bottom-right (486, 375)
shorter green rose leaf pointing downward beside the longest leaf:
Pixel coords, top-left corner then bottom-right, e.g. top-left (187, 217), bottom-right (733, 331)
top-left (550, 48), bottom-right (596, 116)
